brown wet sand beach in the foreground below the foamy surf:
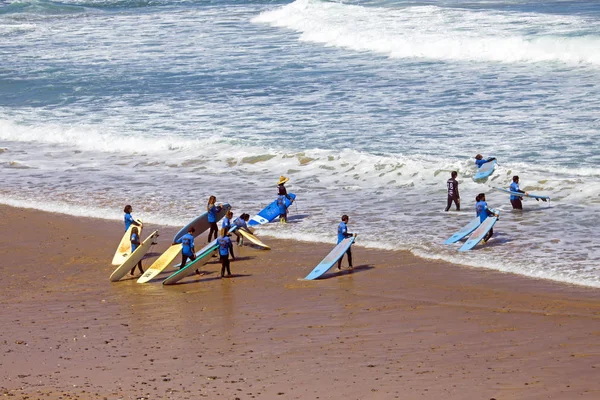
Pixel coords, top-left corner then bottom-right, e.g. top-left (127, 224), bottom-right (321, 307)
top-left (0, 206), bottom-right (600, 400)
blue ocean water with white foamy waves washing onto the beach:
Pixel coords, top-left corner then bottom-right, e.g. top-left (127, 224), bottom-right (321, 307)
top-left (0, 0), bottom-right (600, 287)
